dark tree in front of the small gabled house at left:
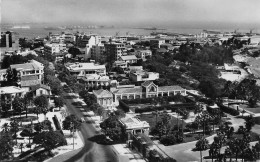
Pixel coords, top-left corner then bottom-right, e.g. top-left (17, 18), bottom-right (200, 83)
top-left (34, 95), bottom-right (49, 118)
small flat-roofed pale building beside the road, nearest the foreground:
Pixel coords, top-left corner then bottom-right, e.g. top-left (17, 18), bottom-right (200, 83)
top-left (119, 114), bottom-right (150, 140)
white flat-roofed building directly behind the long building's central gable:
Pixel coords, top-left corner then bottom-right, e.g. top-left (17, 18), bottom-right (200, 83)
top-left (129, 70), bottom-right (159, 82)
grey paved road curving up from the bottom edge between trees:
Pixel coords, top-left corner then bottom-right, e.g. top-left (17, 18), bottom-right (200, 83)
top-left (49, 94), bottom-right (118, 162)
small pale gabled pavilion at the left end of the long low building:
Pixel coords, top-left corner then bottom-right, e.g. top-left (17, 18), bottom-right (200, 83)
top-left (93, 89), bottom-right (113, 107)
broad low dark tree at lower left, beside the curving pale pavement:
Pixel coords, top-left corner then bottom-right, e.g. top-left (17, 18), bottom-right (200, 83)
top-left (33, 131), bottom-right (67, 152)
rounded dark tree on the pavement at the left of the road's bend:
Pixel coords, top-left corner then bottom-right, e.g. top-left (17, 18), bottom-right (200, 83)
top-left (62, 114), bottom-right (81, 132)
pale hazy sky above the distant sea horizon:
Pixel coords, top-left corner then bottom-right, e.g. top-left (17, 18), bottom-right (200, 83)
top-left (0, 0), bottom-right (260, 28)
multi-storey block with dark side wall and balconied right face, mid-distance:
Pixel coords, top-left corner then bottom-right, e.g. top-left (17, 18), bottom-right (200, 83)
top-left (105, 42), bottom-right (126, 62)
